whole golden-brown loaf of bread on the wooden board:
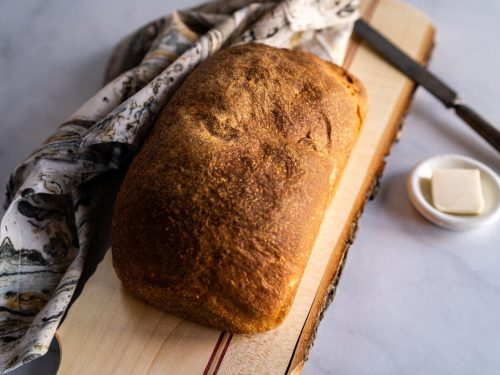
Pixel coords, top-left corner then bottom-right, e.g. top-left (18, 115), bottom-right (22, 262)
top-left (112, 44), bottom-right (366, 333)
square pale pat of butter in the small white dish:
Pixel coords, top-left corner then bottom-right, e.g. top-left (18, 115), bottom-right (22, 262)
top-left (431, 169), bottom-right (484, 215)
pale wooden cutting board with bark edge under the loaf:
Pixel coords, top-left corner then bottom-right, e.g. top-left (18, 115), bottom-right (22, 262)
top-left (56, 0), bottom-right (434, 375)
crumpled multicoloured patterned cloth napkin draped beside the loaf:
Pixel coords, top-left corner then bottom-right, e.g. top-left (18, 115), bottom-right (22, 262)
top-left (0, 0), bottom-right (359, 373)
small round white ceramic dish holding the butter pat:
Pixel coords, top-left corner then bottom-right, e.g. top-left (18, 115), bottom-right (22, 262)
top-left (406, 155), bottom-right (500, 230)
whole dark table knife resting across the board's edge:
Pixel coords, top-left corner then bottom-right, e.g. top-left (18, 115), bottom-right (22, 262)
top-left (354, 19), bottom-right (500, 152)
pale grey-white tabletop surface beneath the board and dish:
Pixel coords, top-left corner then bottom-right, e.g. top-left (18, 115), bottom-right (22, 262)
top-left (0, 0), bottom-right (500, 374)
